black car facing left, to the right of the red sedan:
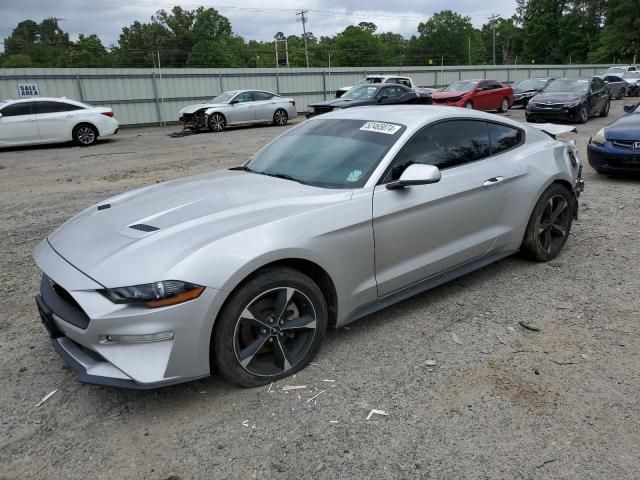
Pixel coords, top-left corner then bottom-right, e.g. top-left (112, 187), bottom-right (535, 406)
top-left (525, 77), bottom-right (611, 123)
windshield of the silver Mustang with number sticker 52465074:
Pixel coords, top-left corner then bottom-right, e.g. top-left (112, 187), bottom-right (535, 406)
top-left (241, 119), bottom-right (406, 188)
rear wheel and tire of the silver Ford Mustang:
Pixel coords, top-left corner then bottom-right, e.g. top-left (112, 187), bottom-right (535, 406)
top-left (520, 183), bottom-right (575, 262)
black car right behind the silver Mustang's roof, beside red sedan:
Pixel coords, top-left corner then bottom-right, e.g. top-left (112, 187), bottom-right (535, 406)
top-left (307, 83), bottom-right (431, 118)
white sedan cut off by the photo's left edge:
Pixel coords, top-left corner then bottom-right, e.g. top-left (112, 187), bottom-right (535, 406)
top-left (0, 97), bottom-right (119, 147)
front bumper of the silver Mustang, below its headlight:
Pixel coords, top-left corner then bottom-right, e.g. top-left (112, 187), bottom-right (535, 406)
top-left (34, 240), bottom-right (228, 389)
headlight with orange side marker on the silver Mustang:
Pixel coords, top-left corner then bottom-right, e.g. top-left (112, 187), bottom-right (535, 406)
top-left (98, 280), bottom-right (204, 308)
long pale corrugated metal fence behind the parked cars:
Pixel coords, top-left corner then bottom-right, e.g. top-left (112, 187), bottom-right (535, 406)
top-left (0, 65), bottom-right (608, 125)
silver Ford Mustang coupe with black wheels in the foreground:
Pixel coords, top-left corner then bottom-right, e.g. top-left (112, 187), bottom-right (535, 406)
top-left (34, 106), bottom-right (583, 388)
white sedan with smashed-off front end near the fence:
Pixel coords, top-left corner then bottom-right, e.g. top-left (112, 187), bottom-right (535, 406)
top-left (178, 90), bottom-right (297, 132)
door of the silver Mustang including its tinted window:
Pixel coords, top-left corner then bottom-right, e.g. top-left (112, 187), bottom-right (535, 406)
top-left (373, 120), bottom-right (507, 296)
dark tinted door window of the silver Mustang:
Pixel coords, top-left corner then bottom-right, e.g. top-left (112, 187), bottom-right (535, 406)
top-left (383, 120), bottom-right (491, 183)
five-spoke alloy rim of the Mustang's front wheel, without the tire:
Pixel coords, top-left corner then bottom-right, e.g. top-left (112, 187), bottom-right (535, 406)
top-left (234, 287), bottom-right (317, 376)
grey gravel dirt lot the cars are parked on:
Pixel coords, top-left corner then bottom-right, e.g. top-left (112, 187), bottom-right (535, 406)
top-left (0, 100), bottom-right (640, 480)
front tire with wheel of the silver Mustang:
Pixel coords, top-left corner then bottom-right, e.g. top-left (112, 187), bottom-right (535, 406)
top-left (211, 267), bottom-right (328, 387)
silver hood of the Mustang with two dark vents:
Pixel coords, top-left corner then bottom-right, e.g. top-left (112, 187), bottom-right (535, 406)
top-left (48, 170), bottom-right (351, 288)
